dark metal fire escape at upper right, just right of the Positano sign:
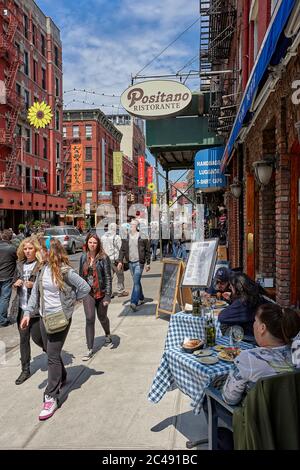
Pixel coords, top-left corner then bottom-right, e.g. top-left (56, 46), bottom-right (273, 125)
top-left (200, 0), bottom-right (238, 136)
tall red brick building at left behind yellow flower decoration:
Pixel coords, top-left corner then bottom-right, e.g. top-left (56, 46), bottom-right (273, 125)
top-left (0, 0), bottom-right (66, 229)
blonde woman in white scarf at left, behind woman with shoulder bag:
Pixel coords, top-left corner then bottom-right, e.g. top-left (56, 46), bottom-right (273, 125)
top-left (10, 236), bottom-right (43, 385)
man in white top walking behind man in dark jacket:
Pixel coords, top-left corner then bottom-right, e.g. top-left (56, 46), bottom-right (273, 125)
top-left (101, 223), bottom-right (129, 297)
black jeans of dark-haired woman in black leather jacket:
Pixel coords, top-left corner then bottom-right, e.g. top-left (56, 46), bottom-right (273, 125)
top-left (83, 294), bottom-right (110, 349)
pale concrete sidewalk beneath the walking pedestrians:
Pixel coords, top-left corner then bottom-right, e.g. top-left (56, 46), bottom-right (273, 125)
top-left (0, 262), bottom-right (207, 450)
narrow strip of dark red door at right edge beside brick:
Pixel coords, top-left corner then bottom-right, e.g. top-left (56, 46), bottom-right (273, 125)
top-left (291, 153), bottom-right (300, 307)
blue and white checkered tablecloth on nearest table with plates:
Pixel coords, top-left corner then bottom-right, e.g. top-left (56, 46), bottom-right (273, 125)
top-left (148, 337), bottom-right (253, 414)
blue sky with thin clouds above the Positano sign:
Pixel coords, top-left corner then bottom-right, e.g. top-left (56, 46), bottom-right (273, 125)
top-left (36, 0), bottom-right (199, 184)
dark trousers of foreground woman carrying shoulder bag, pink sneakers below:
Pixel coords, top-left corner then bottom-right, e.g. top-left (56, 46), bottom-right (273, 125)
top-left (40, 318), bottom-right (72, 398)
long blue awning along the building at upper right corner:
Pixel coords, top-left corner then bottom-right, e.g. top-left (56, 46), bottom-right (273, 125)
top-left (221, 0), bottom-right (296, 171)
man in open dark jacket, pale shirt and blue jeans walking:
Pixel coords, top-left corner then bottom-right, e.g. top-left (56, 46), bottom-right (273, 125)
top-left (118, 219), bottom-right (150, 312)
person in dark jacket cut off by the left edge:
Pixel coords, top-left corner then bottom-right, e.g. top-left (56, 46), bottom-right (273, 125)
top-left (0, 230), bottom-right (17, 327)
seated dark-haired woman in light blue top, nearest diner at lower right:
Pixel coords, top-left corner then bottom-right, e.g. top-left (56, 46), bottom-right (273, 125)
top-left (211, 303), bottom-right (300, 450)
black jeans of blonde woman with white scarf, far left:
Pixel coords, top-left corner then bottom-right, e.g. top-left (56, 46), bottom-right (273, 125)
top-left (17, 309), bottom-right (44, 370)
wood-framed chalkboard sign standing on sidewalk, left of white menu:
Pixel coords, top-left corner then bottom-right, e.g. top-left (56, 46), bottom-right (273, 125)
top-left (156, 260), bottom-right (181, 317)
